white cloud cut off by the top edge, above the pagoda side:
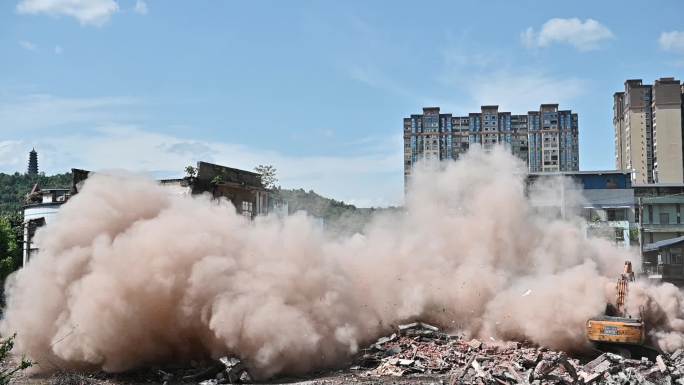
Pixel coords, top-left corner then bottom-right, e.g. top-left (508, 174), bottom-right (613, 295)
top-left (17, 0), bottom-right (119, 26)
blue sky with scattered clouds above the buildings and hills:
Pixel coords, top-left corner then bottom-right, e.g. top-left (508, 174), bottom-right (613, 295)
top-left (0, 0), bottom-right (684, 206)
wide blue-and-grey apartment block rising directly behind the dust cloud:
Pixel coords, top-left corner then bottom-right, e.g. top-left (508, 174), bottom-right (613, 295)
top-left (404, 104), bottom-right (579, 186)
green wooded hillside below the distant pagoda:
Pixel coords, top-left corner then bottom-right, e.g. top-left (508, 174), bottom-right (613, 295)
top-left (0, 172), bottom-right (71, 215)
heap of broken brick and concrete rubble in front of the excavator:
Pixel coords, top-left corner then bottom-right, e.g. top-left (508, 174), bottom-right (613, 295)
top-left (352, 322), bottom-right (684, 385)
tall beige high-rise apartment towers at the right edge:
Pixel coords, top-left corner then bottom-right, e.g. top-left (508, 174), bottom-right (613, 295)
top-left (613, 78), bottom-right (684, 184)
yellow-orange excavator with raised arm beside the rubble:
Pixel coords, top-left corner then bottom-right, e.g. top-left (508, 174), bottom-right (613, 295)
top-left (587, 261), bottom-right (658, 360)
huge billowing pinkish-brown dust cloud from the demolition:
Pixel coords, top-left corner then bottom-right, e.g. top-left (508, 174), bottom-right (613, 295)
top-left (0, 149), bottom-right (684, 378)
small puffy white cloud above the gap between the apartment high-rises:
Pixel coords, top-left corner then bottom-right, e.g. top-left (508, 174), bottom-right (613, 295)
top-left (520, 18), bottom-right (615, 51)
